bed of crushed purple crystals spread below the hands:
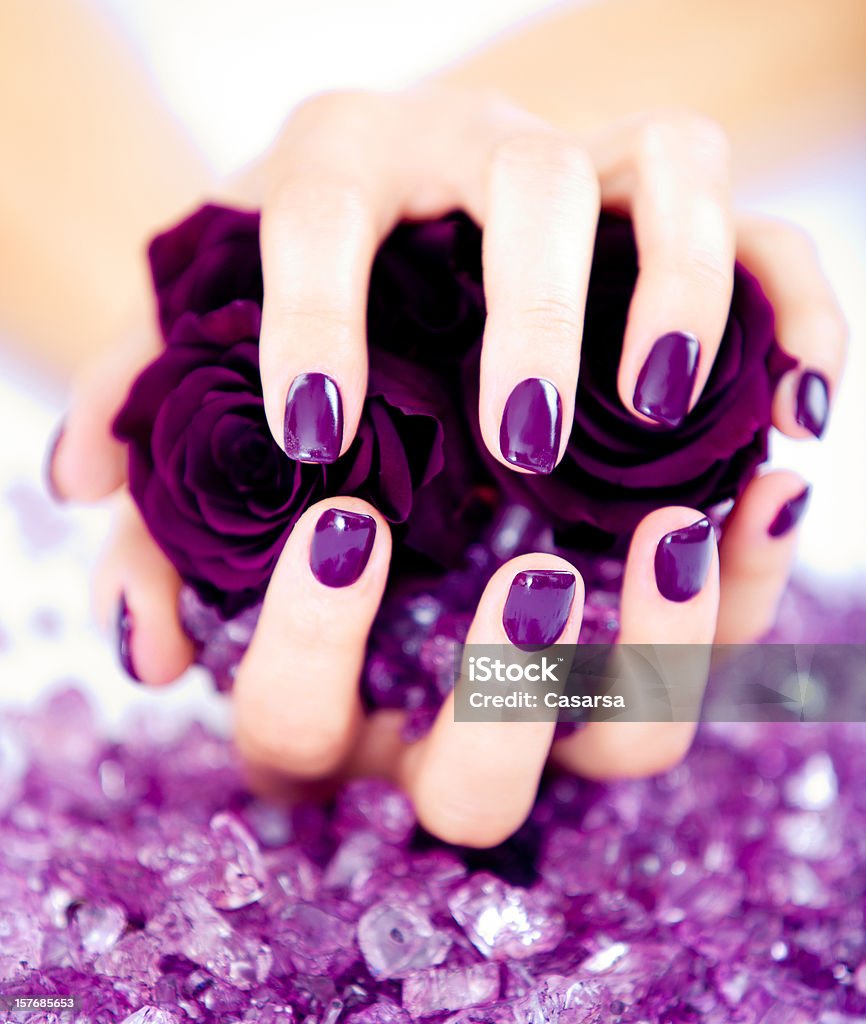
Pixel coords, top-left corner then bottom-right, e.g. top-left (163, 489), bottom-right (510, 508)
top-left (0, 691), bottom-right (866, 1024)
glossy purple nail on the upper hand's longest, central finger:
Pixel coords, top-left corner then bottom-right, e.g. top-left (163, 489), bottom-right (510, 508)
top-left (500, 377), bottom-right (562, 473)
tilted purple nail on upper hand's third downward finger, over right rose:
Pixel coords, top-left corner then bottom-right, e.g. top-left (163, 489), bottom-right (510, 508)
top-left (635, 331), bottom-right (700, 427)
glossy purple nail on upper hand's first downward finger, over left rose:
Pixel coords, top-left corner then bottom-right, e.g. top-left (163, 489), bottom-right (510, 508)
top-left (283, 374), bottom-right (343, 463)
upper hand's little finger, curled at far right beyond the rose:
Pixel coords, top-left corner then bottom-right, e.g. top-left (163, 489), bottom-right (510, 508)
top-left (738, 217), bottom-right (848, 438)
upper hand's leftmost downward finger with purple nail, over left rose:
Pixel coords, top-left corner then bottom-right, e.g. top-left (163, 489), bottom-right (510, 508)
top-left (260, 93), bottom-right (404, 464)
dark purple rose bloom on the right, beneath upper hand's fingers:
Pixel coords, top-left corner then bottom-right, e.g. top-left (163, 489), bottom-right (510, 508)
top-left (465, 214), bottom-right (795, 550)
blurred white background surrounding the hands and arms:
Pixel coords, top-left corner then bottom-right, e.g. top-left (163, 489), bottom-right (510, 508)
top-left (0, 0), bottom-right (866, 720)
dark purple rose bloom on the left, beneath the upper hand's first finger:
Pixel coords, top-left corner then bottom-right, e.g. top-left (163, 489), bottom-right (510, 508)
top-left (115, 206), bottom-right (481, 615)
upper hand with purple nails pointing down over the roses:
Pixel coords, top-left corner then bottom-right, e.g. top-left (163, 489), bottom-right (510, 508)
top-left (49, 88), bottom-right (846, 496)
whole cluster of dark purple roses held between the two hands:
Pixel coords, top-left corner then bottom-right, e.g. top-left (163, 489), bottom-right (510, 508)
top-left (115, 206), bottom-right (793, 616)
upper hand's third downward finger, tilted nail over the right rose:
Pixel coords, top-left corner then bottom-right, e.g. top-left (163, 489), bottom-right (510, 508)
top-left (591, 115), bottom-right (735, 428)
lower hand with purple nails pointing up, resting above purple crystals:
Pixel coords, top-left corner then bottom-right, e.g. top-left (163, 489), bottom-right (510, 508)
top-left (90, 471), bottom-right (818, 846)
